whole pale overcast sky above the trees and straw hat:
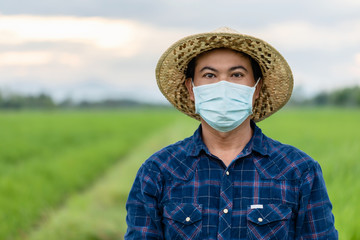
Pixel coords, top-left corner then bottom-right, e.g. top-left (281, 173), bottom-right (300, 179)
top-left (0, 0), bottom-right (360, 101)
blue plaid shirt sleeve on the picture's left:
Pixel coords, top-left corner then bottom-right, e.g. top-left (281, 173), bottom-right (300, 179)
top-left (124, 164), bottom-right (163, 240)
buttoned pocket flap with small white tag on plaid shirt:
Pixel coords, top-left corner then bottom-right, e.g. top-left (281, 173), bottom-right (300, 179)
top-left (247, 204), bottom-right (292, 225)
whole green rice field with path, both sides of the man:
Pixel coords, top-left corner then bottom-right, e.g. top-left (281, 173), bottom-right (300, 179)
top-left (0, 108), bottom-right (360, 240)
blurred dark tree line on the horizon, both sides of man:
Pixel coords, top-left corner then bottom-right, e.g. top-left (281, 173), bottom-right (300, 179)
top-left (0, 86), bottom-right (360, 109)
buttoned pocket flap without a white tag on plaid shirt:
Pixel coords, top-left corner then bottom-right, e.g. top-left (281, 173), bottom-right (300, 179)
top-left (163, 203), bottom-right (202, 225)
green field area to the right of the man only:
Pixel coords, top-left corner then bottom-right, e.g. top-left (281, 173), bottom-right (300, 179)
top-left (259, 109), bottom-right (360, 240)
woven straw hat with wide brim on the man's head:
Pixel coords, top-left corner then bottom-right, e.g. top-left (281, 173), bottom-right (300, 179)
top-left (156, 27), bottom-right (293, 122)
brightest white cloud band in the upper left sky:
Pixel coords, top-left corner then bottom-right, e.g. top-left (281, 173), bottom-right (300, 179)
top-left (0, 15), bottom-right (142, 56)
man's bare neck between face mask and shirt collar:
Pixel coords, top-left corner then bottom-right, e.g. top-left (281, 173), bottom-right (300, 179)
top-left (201, 118), bottom-right (253, 166)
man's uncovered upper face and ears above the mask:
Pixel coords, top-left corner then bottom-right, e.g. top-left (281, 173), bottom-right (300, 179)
top-left (186, 48), bottom-right (261, 102)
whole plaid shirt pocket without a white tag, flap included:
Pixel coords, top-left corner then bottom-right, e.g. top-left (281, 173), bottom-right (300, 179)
top-left (163, 203), bottom-right (202, 239)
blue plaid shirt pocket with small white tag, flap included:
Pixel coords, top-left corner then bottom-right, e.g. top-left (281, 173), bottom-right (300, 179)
top-left (247, 204), bottom-right (292, 240)
